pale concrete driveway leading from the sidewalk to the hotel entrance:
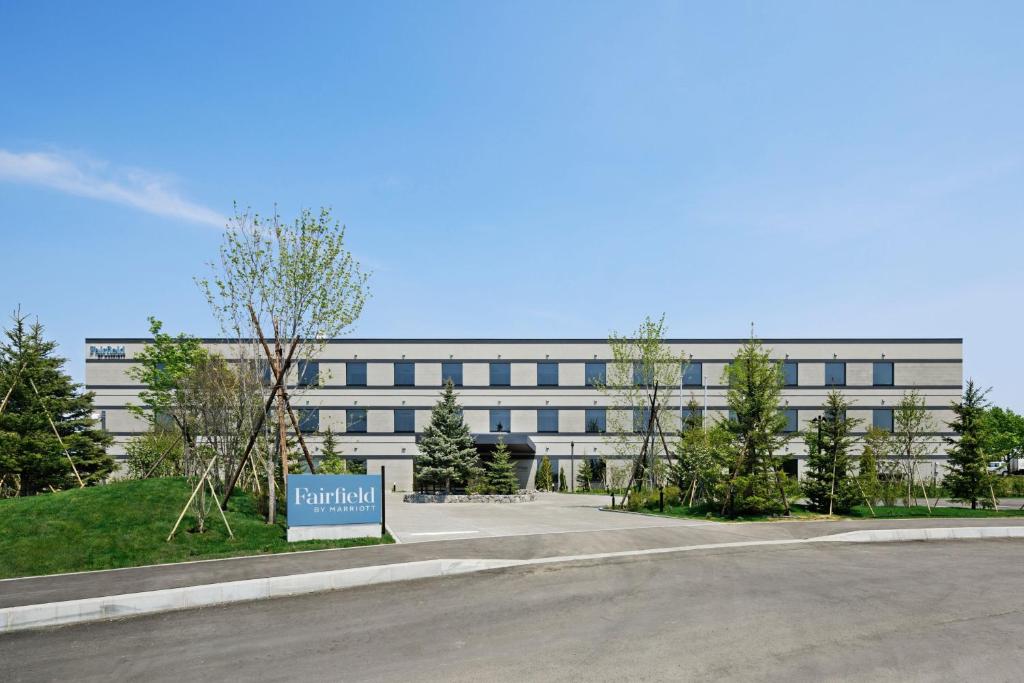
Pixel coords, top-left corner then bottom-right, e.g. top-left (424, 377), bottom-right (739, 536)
top-left (387, 494), bottom-right (717, 543)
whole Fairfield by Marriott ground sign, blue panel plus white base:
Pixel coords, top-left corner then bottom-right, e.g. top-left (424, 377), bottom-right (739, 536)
top-left (288, 474), bottom-right (384, 541)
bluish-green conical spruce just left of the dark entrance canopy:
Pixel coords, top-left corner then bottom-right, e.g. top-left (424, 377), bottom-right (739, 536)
top-left (416, 379), bottom-right (479, 493)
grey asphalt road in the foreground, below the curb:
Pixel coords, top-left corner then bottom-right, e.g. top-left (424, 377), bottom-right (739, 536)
top-left (0, 541), bottom-right (1024, 682)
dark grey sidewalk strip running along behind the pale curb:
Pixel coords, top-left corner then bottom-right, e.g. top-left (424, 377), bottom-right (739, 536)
top-left (8, 512), bottom-right (1024, 608)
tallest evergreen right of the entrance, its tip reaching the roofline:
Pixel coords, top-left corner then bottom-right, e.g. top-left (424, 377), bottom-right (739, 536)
top-left (719, 337), bottom-right (790, 517)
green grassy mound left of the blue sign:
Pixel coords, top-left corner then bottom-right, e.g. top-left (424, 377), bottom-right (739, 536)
top-left (0, 478), bottom-right (392, 579)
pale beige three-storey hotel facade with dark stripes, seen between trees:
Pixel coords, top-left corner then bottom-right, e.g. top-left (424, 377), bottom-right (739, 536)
top-left (85, 338), bottom-right (963, 490)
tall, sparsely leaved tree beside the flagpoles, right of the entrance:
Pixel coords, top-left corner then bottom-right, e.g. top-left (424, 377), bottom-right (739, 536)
top-left (588, 314), bottom-right (688, 487)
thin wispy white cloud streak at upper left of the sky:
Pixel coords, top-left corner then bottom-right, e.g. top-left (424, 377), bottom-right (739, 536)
top-left (0, 150), bottom-right (226, 227)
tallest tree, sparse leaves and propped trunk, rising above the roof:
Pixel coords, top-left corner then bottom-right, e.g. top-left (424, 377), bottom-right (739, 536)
top-left (197, 209), bottom-right (368, 522)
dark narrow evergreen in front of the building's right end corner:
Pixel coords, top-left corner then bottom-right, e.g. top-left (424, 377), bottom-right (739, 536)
top-left (943, 380), bottom-right (992, 510)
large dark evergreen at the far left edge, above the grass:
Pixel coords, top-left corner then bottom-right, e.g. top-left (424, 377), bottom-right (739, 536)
top-left (0, 313), bottom-right (115, 495)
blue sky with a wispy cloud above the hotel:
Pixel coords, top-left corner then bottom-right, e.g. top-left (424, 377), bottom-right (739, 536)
top-left (0, 2), bottom-right (1024, 410)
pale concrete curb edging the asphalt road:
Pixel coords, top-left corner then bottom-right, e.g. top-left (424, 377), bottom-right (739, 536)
top-left (0, 526), bottom-right (1024, 634)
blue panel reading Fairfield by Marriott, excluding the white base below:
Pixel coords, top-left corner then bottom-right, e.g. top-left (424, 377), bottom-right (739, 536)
top-left (288, 474), bottom-right (383, 526)
